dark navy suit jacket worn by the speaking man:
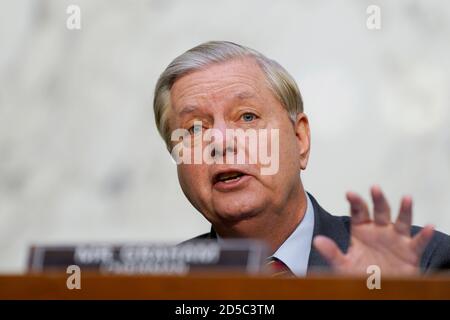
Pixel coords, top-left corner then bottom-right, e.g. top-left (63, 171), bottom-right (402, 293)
top-left (187, 194), bottom-right (450, 272)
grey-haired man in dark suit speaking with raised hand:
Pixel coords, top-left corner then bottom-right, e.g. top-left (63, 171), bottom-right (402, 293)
top-left (154, 41), bottom-right (450, 276)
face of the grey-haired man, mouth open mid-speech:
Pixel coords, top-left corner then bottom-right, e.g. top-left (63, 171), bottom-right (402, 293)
top-left (169, 58), bottom-right (309, 230)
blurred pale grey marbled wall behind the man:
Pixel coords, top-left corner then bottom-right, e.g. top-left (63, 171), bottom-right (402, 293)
top-left (0, 0), bottom-right (450, 272)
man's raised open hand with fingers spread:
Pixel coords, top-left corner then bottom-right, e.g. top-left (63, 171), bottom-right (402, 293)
top-left (314, 187), bottom-right (433, 275)
